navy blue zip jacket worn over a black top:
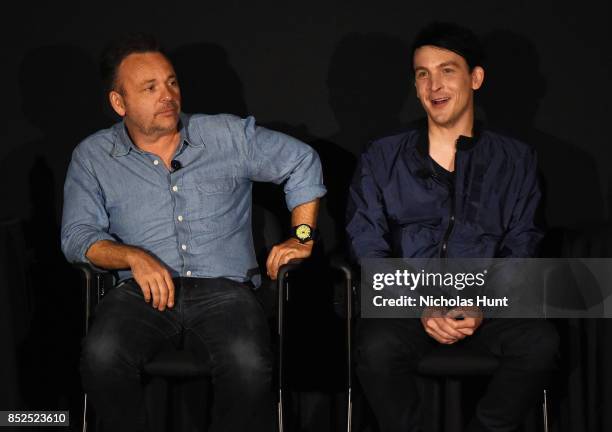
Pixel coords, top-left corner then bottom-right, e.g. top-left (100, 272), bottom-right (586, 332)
top-left (347, 125), bottom-right (542, 261)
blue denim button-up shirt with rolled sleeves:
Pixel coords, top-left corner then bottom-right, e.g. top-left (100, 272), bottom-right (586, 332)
top-left (62, 114), bottom-right (326, 282)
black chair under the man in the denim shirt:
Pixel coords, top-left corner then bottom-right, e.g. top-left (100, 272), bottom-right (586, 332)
top-left (75, 260), bottom-right (302, 432)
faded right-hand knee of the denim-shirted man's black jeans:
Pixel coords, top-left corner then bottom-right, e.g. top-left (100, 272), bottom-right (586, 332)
top-left (227, 339), bottom-right (272, 382)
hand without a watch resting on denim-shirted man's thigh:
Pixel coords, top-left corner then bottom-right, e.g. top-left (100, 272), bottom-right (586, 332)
top-left (127, 248), bottom-right (174, 311)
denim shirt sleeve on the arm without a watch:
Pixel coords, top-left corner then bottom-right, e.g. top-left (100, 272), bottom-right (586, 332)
top-left (61, 147), bottom-right (114, 262)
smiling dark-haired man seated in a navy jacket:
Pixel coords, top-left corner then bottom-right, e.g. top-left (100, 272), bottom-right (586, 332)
top-left (347, 23), bottom-right (558, 432)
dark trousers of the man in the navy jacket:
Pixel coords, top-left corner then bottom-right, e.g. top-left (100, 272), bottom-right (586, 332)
top-left (357, 319), bottom-right (559, 432)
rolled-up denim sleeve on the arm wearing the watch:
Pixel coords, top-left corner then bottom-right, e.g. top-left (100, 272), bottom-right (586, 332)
top-left (243, 117), bottom-right (326, 211)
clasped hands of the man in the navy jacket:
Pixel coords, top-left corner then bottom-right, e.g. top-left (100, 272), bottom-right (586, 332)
top-left (421, 308), bottom-right (482, 345)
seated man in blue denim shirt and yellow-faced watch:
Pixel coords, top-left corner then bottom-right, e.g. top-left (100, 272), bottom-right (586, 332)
top-left (62, 35), bottom-right (325, 431)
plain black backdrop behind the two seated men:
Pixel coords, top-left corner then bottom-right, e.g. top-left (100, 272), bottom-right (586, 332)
top-left (0, 0), bottom-right (612, 431)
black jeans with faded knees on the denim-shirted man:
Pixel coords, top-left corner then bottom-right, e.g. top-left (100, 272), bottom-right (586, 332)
top-left (81, 278), bottom-right (274, 432)
